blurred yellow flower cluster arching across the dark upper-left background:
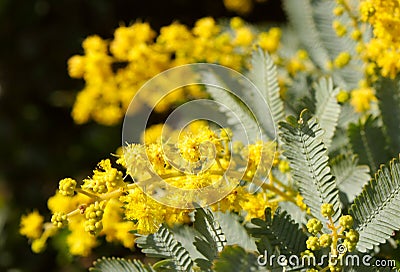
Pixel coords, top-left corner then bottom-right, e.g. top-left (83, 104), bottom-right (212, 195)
top-left (68, 17), bottom-right (280, 125)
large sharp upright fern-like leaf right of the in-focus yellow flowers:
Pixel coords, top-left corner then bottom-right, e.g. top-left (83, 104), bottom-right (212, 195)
top-left (280, 111), bottom-right (341, 221)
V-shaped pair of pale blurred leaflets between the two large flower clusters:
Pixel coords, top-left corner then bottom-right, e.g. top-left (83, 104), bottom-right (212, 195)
top-left (202, 48), bottom-right (284, 140)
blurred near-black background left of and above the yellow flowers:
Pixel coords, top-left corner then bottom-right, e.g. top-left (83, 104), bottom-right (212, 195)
top-left (0, 0), bottom-right (284, 271)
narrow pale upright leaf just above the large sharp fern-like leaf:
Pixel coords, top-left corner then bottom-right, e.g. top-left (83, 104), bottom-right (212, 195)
top-left (314, 78), bottom-right (340, 148)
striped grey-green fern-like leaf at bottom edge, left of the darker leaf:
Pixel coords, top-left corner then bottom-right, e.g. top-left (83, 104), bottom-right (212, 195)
top-left (136, 225), bottom-right (193, 271)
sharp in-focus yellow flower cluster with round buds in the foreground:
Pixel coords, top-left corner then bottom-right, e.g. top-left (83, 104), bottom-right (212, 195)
top-left (20, 122), bottom-right (300, 256)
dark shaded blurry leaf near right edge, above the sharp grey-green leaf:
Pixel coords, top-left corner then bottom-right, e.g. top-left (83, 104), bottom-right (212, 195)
top-left (348, 115), bottom-right (390, 172)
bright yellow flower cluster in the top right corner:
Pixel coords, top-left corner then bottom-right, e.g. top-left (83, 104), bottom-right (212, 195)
top-left (360, 0), bottom-right (400, 78)
